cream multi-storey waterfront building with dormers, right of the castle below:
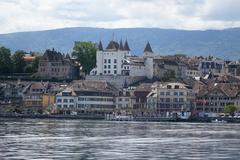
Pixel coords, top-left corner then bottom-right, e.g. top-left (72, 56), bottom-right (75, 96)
top-left (147, 82), bottom-right (195, 115)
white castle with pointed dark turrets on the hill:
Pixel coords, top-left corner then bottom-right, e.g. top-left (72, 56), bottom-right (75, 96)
top-left (90, 41), bottom-right (154, 79)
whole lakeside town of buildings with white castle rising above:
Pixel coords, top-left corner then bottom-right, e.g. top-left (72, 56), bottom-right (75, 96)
top-left (0, 40), bottom-right (240, 121)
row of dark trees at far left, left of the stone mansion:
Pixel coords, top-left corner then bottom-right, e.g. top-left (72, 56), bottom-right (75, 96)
top-left (0, 47), bottom-right (39, 75)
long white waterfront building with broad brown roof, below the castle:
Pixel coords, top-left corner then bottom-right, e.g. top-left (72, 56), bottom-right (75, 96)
top-left (56, 81), bottom-right (116, 113)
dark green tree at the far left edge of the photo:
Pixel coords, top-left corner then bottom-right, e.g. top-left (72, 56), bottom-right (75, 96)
top-left (0, 47), bottom-right (12, 75)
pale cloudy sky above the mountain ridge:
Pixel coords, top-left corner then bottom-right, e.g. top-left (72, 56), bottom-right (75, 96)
top-left (0, 0), bottom-right (240, 33)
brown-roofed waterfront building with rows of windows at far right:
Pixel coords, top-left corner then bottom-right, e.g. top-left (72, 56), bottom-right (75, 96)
top-left (194, 75), bottom-right (240, 113)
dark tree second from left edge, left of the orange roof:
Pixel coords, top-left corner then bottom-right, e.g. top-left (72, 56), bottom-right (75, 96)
top-left (12, 50), bottom-right (27, 73)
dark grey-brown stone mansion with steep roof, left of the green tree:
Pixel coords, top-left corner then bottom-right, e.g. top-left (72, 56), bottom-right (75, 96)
top-left (36, 49), bottom-right (80, 79)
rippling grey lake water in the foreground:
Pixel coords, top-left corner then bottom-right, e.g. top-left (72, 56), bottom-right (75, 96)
top-left (0, 119), bottom-right (240, 160)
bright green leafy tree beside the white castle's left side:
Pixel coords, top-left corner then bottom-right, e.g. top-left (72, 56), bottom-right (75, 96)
top-left (72, 42), bottom-right (97, 74)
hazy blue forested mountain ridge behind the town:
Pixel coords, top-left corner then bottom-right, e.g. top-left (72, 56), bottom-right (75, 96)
top-left (0, 27), bottom-right (240, 59)
